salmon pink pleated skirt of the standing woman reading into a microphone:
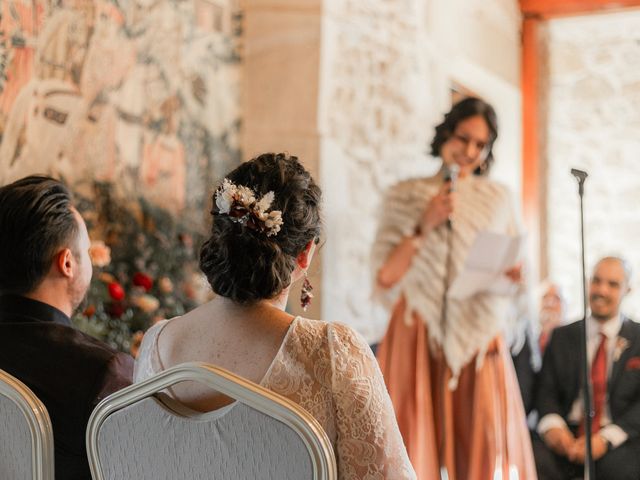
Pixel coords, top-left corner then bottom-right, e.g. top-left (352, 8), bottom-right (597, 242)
top-left (378, 299), bottom-right (537, 480)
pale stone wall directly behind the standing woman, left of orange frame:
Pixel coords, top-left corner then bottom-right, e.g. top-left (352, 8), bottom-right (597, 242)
top-left (319, 0), bottom-right (520, 341)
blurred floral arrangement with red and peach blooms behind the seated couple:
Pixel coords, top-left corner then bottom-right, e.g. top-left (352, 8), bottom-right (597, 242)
top-left (73, 183), bottom-right (210, 356)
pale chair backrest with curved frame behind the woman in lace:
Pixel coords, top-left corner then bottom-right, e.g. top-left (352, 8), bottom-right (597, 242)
top-left (87, 363), bottom-right (337, 480)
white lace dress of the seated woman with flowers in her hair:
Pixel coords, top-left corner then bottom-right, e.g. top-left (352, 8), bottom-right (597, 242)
top-left (134, 317), bottom-right (416, 480)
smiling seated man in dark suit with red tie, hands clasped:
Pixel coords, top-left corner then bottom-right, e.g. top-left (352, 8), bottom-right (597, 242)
top-left (533, 257), bottom-right (640, 480)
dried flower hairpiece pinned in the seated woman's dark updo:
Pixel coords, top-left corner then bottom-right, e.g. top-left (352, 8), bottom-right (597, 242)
top-left (216, 178), bottom-right (282, 237)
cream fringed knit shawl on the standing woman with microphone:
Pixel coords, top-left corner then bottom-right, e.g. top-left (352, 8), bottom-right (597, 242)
top-left (372, 175), bottom-right (527, 387)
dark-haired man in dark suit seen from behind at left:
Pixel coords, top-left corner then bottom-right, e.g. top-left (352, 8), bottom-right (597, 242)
top-left (0, 177), bottom-right (133, 480)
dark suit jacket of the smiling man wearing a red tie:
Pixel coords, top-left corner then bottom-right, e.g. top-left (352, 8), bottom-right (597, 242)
top-left (536, 319), bottom-right (640, 440)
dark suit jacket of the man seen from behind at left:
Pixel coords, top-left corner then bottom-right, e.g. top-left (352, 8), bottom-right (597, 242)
top-left (0, 295), bottom-right (133, 480)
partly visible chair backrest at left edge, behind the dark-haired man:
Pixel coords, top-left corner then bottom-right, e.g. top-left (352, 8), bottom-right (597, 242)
top-left (0, 370), bottom-right (54, 480)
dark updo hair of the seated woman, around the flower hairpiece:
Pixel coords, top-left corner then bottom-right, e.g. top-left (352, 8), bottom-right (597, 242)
top-left (200, 153), bottom-right (322, 304)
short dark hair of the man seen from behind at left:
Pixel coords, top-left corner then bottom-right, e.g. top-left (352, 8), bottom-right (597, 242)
top-left (0, 176), bottom-right (78, 295)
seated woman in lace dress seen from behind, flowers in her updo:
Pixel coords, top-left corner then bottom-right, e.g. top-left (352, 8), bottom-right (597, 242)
top-left (134, 153), bottom-right (415, 479)
